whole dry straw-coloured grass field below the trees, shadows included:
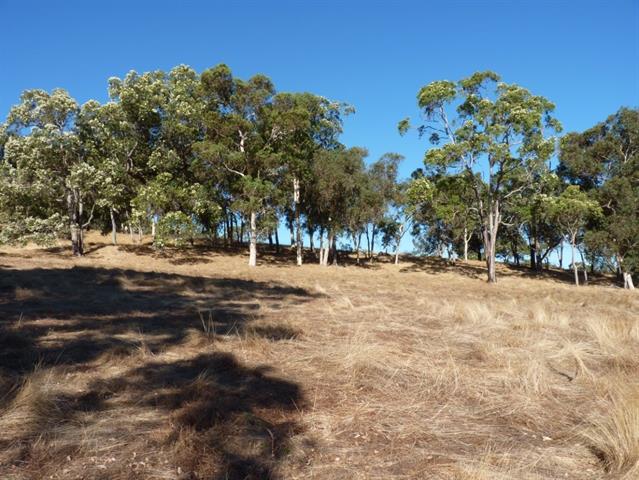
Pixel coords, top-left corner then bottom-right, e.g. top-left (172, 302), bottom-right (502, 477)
top-left (0, 232), bottom-right (639, 480)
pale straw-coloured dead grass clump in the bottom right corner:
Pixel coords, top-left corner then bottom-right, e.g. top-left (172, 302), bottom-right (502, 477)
top-left (583, 384), bottom-right (639, 473)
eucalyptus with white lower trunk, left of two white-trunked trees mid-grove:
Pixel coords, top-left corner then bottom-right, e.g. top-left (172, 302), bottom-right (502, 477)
top-left (194, 65), bottom-right (283, 267)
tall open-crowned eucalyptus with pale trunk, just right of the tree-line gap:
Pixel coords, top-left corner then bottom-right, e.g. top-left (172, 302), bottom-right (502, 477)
top-left (399, 71), bottom-right (561, 282)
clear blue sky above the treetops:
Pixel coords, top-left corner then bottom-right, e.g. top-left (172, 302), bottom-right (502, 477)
top-left (0, 0), bottom-right (639, 253)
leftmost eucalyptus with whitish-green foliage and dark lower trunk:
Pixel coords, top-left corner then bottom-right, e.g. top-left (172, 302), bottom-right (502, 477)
top-left (2, 89), bottom-right (102, 255)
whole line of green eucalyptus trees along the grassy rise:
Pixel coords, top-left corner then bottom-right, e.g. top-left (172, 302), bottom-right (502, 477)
top-left (0, 65), bottom-right (639, 288)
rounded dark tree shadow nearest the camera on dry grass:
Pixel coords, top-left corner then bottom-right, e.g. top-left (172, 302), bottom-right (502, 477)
top-left (92, 353), bottom-right (304, 480)
